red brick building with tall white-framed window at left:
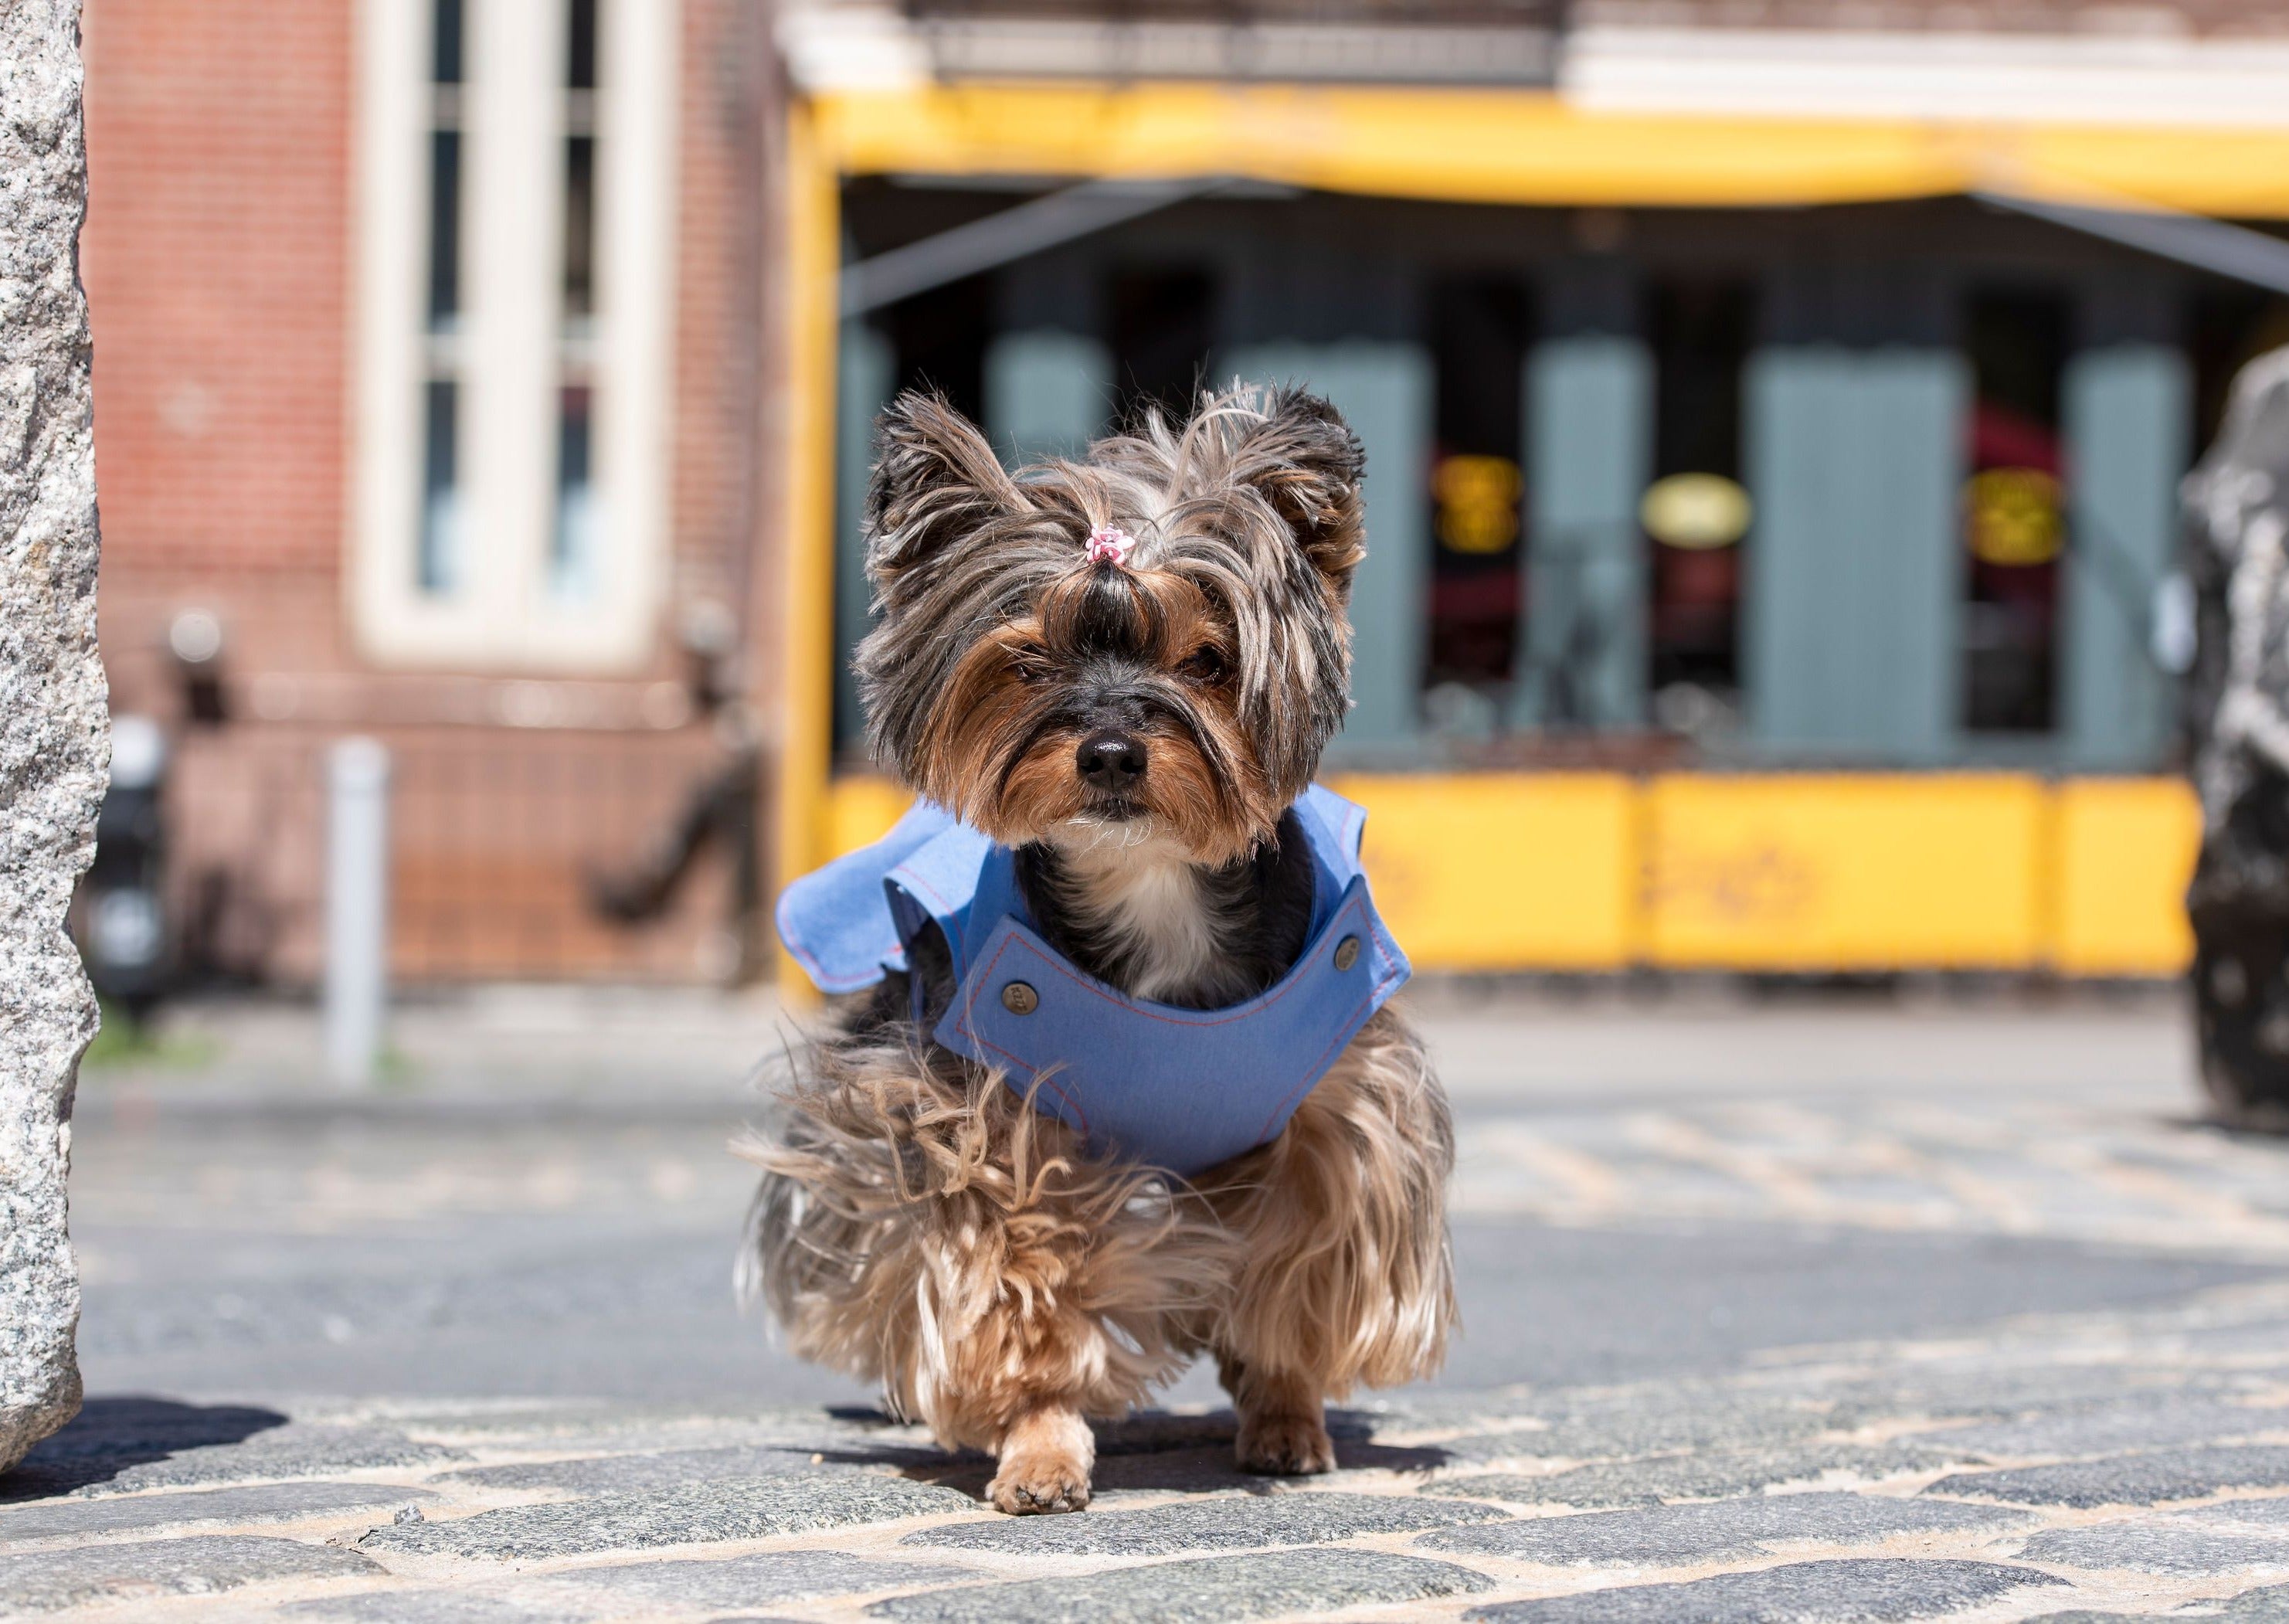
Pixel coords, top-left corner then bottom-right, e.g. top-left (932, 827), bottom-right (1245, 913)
top-left (83, 0), bottom-right (773, 980)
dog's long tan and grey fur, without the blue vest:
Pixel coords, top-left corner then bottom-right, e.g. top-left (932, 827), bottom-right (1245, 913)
top-left (739, 394), bottom-right (1455, 1512)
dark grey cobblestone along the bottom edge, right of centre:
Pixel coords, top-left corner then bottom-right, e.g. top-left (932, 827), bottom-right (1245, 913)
top-left (1462, 1558), bottom-right (2065, 1624)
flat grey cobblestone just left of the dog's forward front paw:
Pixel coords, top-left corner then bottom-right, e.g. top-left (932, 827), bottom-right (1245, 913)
top-left (357, 1473), bottom-right (977, 1562)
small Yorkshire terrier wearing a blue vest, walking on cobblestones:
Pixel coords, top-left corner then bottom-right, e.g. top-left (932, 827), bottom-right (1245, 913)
top-left (742, 389), bottom-right (1455, 1512)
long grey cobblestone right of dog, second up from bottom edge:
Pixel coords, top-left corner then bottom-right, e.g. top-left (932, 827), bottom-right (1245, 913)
top-left (1414, 1493), bottom-right (2035, 1567)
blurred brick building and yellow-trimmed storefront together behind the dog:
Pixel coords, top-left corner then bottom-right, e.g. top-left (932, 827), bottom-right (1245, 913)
top-left (85, 0), bottom-right (2289, 983)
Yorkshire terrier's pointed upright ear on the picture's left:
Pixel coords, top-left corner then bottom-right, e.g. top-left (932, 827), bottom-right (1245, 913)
top-left (865, 389), bottom-right (1025, 584)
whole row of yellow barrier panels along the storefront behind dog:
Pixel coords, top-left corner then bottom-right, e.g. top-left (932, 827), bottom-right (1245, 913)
top-left (827, 772), bottom-right (2199, 976)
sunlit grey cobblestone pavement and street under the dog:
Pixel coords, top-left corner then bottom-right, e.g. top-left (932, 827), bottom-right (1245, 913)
top-left (22, 980), bottom-right (2289, 1624)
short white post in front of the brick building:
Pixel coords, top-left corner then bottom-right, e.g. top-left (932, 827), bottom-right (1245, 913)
top-left (325, 738), bottom-right (389, 1083)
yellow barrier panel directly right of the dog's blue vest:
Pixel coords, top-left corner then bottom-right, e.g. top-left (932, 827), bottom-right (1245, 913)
top-left (1332, 772), bottom-right (1639, 971)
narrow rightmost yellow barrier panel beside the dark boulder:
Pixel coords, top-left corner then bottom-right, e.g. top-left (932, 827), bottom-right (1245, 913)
top-left (2051, 779), bottom-right (2202, 976)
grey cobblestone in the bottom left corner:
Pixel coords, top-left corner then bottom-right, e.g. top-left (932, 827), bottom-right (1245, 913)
top-left (0, 1534), bottom-right (382, 1612)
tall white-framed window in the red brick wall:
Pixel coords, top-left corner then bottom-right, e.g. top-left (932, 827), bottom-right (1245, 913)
top-left (348, 0), bottom-right (680, 674)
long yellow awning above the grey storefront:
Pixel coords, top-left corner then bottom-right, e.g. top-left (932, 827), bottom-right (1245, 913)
top-left (813, 85), bottom-right (2289, 218)
